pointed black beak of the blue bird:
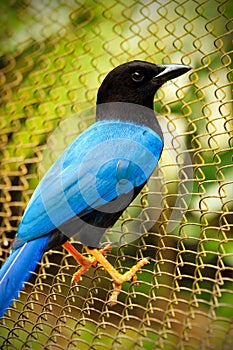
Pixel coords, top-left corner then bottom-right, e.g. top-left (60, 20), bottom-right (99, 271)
top-left (152, 64), bottom-right (192, 85)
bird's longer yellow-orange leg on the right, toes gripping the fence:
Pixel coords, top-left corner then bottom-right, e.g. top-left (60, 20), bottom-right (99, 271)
top-left (85, 247), bottom-right (149, 305)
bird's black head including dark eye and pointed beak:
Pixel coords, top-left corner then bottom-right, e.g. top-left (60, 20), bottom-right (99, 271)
top-left (97, 61), bottom-right (191, 109)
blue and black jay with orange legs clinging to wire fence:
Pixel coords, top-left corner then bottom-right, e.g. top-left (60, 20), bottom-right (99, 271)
top-left (0, 60), bottom-right (191, 316)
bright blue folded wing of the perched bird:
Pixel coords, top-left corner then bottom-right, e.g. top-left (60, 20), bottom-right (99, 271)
top-left (15, 121), bottom-right (163, 247)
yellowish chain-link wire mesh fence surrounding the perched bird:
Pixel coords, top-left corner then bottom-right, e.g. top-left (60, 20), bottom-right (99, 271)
top-left (0, 0), bottom-right (233, 350)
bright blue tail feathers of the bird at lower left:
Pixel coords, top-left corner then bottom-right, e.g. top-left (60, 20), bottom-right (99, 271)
top-left (0, 235), bottom-right (50, 317)
